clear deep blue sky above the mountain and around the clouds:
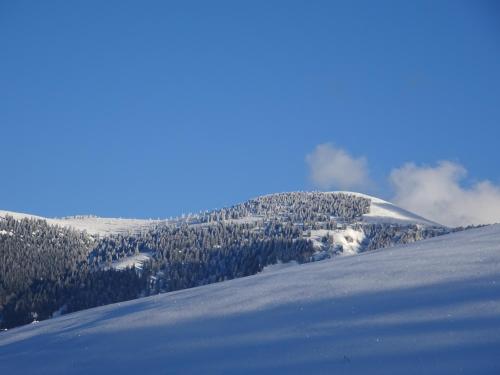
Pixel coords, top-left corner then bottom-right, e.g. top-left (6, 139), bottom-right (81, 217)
top-left (0, 0), bottom-right (500, 217)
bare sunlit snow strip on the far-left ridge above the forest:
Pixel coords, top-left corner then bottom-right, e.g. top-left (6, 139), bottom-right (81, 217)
top-left (0, 210), bottom-right (165, 235)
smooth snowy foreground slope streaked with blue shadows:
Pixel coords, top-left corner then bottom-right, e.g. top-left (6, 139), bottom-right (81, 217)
top-left (0, 225), bottom-right (500, 374)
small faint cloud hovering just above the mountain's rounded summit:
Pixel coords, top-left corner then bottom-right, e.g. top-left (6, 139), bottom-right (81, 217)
top-left (306, 143), bottom-right (369, 190)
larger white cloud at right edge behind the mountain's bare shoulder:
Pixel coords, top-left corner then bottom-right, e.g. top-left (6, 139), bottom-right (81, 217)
top-left (390, 161), bottom-right (500, 226)
